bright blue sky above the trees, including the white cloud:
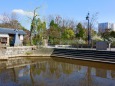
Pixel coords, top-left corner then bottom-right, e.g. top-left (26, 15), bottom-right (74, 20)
top-left (0, 0), bottom-right (115, 29)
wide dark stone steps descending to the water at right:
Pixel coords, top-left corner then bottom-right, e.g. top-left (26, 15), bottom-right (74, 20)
top-left (51, 49), bottom-right (115, 63)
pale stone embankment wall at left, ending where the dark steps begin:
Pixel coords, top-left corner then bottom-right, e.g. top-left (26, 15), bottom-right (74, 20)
top-left (0, 46), bottom-right (53, 60)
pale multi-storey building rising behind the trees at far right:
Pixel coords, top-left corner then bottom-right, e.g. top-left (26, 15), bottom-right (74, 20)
top-left (98, 22), bottom-right (115, 33)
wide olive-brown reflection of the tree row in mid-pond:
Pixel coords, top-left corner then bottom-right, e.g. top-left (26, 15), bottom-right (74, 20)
top-left (32, 61), bottom-right (80, 78)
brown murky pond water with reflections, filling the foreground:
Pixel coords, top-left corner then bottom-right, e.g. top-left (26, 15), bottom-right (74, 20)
top-left (0, 57), bottom-right (115, 86)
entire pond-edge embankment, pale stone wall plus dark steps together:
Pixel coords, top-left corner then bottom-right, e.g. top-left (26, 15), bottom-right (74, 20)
top-left (0, 46), bottom-right (115, 63)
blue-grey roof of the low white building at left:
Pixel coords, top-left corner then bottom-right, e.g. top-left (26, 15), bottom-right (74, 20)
top-left (0, 27), bottom-right (26, 35)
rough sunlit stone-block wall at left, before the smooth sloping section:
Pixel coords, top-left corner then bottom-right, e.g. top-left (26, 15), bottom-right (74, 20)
top-left (0, 46), bottom-right (36, 59)
